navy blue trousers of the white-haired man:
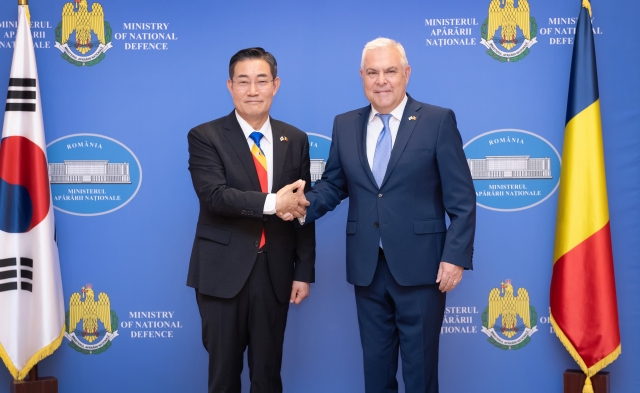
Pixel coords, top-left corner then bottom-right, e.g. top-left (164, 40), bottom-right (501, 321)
top-left (355, 251), bottom-right (446, 393)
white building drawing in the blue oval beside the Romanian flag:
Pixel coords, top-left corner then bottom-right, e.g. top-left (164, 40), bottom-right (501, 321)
top-left (467, 156), bottom-right (552, 180)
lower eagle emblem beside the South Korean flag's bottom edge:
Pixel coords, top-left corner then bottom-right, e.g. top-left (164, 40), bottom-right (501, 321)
top-left (64, 284), bottom-right (118, 355)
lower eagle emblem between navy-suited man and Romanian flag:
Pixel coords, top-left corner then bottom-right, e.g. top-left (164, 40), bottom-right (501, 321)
top-left (482, 280), bottom-right (538, 349)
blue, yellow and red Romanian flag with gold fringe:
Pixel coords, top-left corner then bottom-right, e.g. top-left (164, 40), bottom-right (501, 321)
top-left (550, 0), bottom-right (620, 393)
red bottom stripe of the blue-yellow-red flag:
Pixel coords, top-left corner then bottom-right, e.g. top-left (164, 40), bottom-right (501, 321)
top-left (550, 222), bottom-right (620, 367)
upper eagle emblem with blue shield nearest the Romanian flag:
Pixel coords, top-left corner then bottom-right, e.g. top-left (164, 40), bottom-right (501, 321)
top-left (480, 0), bottom-right (538, 62)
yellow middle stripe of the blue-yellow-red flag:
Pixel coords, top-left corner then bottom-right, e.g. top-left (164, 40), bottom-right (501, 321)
top-left (553, 99), bottom-right (609, 263)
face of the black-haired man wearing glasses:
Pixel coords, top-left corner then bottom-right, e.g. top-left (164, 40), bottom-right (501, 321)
top-left (227, 59), bottom-right (280, 123)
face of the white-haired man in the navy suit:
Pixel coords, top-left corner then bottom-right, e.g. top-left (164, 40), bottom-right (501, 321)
top-left (360, 47), bottom-right (411, 114)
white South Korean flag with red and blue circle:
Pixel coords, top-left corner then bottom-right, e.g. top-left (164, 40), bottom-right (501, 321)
top-left (0, 0), bottom-right (64, 380)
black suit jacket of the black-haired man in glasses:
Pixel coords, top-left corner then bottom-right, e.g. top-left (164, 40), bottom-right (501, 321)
top-left (187, 111), bottom-right (315, 303)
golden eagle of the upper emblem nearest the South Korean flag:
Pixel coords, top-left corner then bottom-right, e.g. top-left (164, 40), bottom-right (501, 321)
top-left (62, 0), bottom-right (105, 55)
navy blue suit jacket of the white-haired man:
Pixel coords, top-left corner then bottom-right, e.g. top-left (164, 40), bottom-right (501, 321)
top-left (306, 97), bottom-right (476, 286)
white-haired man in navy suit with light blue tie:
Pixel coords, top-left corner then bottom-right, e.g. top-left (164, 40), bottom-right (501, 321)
top-left (301, 38), bottom-right (476, 393)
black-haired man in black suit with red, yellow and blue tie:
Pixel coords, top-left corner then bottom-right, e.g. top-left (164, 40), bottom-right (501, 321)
top-left (187, 48), bottom-right (315, 393)
